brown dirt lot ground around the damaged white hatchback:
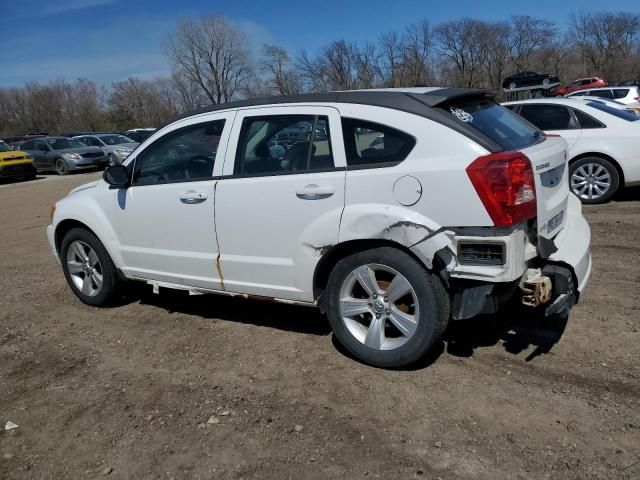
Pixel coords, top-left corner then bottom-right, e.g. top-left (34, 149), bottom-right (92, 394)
top-left (0, 174), bottom-right (640, 480)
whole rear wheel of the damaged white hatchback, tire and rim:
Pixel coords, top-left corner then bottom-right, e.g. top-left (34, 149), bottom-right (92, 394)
top-left (327, 247), bottom-right (449, 368)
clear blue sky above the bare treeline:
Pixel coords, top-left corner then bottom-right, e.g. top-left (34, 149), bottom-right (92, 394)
top-left (0, 0), bottom-right (640, 86)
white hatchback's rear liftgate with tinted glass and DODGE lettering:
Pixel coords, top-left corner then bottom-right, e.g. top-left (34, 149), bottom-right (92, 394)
top-left (438, 95), bottom-right (569, 238)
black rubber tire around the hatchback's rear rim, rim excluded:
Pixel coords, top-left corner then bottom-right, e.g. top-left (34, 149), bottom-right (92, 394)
top-left (326, 247), bottom-right (450, 368)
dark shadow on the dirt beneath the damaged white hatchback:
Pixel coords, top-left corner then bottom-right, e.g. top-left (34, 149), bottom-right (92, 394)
top-left (122, 284), bottom-right (567, 370)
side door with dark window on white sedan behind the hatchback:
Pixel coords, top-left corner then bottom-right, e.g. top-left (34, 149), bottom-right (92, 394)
top-left (518, 103), bottom-right (582, 150)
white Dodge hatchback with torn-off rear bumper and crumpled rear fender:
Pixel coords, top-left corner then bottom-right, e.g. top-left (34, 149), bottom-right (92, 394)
top-left (47, 88), bottom-right (591, 367)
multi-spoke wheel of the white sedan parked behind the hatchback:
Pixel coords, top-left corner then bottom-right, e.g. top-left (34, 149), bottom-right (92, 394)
top-left (569, 157), bottom-right (620, 204)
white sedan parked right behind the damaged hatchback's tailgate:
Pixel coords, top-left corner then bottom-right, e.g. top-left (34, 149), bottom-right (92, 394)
top-left (503, 98), bottom-right (640, 203)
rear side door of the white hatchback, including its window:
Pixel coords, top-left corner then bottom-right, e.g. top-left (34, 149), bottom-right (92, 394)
top-left (215, 106), bottom-right (346, 301)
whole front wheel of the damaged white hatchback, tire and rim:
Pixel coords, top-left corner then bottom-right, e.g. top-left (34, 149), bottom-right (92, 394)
top-left (60, 228), bottom-right (118, 306)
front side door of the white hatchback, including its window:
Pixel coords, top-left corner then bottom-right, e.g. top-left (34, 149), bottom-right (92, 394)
top-left (111, 113), bottom-right (234, 289)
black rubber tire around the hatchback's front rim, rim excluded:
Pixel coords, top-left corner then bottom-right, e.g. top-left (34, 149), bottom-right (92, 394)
top-left (60, 228), bottom-right (119, 307)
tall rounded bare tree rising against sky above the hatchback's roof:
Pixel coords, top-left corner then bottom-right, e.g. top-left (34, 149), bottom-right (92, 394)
top-left (167, 16), bottom-right (253, 104)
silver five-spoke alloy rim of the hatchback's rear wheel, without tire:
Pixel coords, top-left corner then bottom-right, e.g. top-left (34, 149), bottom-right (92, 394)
top-left (340, 263), bottom-right (419, 350)
